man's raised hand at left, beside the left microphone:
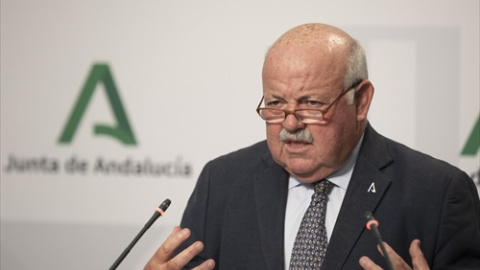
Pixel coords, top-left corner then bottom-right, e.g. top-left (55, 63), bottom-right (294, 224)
top-left (144, 226), bottom-right (215, 270)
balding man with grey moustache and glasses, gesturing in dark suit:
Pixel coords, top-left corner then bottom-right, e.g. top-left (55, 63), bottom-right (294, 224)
top-left (145, 24), bottom-right (480, 270)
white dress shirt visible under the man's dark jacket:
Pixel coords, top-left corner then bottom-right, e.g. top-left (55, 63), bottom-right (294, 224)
top-left (285, 137), bottom-right (363, 269)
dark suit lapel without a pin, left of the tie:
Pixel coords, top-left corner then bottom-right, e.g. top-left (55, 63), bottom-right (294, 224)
top-left (254, 151), bottom-right (288, 270)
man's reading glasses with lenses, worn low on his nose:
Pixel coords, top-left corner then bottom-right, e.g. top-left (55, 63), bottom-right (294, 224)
top-left (257, 80), bottom-right (362, 124)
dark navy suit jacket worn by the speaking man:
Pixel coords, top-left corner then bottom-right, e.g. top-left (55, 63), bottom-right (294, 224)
top-left (177, 126), bottom-right (480, 270)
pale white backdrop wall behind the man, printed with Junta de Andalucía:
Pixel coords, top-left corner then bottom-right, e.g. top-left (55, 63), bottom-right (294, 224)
top-left (0, 0), bottom-right (480, 270)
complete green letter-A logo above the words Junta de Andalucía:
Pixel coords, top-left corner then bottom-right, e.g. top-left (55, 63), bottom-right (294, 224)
top-left (58, 63), bottom-right (137, 145)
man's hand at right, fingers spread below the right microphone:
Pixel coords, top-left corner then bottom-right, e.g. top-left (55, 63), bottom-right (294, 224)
top-left (360, 239), bottom-right (430, 270)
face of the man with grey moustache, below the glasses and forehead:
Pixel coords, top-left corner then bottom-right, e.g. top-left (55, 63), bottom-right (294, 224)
top-left (263, 45), bottom-right (361, 183)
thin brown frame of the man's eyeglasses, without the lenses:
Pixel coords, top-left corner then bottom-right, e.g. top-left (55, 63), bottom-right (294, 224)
top-left (256, 79), bottom-right (363, 124)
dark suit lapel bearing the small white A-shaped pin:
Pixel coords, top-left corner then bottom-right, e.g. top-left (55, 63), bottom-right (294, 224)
top-left (323, 127), bottom-right (392, 269)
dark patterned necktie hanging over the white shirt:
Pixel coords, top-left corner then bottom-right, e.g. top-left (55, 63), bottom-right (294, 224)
top-left (290, 179), bottom-right (334, 270)
